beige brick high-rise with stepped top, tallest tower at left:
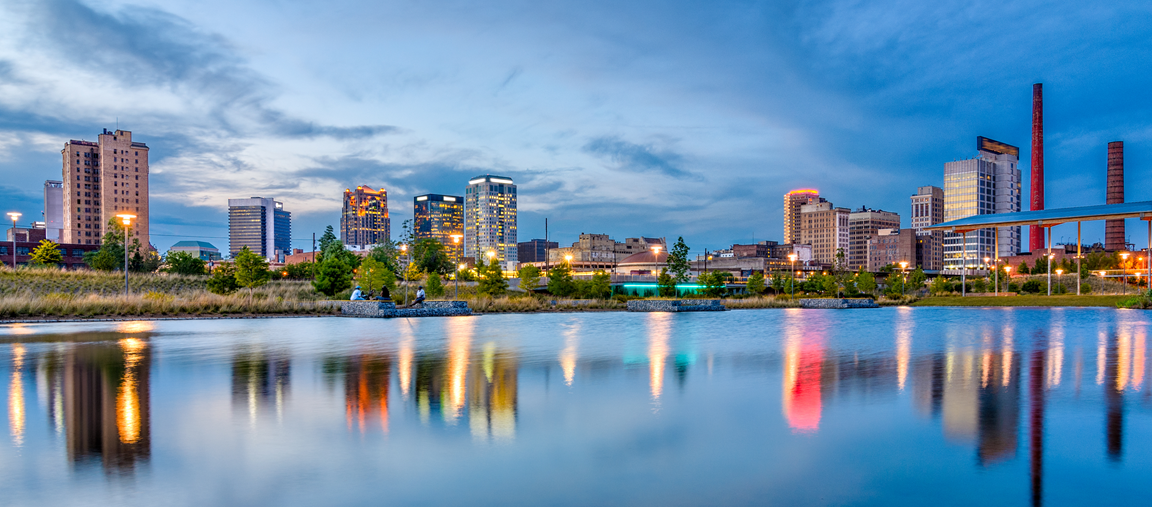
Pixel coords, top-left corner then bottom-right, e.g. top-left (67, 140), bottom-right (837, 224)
top-left (60, 129), bottom-right (149, 248)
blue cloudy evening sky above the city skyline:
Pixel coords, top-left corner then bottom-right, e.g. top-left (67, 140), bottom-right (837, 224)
top-left (0, 0), bottom-right (1152, 251)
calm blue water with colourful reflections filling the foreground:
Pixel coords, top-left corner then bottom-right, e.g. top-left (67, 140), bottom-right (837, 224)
top-left (0, 308), bottom-right (1152, 506)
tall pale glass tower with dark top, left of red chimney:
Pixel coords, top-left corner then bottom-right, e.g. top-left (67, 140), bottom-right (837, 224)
top-left (943, 137), bottom-right (1021, 270)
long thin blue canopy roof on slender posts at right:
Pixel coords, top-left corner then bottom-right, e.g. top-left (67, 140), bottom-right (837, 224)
top-left (924, 200), bottom-right (1152, 233)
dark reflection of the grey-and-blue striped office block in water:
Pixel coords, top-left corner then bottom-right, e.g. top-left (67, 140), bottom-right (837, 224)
top-left (232, 349), bottom-right (291, 426)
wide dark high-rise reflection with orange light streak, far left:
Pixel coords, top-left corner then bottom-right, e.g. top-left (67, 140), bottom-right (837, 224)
top-left (41, 336), bottom-right (152, 474)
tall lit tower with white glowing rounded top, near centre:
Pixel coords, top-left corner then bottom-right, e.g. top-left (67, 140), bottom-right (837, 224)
top-left (464, 174), bottom-right (518, 271)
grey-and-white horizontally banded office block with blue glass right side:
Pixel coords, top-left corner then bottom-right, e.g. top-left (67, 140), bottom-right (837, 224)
top-left (228, 197), bottom-right (291, 262)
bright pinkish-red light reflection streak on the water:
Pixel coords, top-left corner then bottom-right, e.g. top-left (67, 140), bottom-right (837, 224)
top-left (783, 310), bottom-right (824, 432)
